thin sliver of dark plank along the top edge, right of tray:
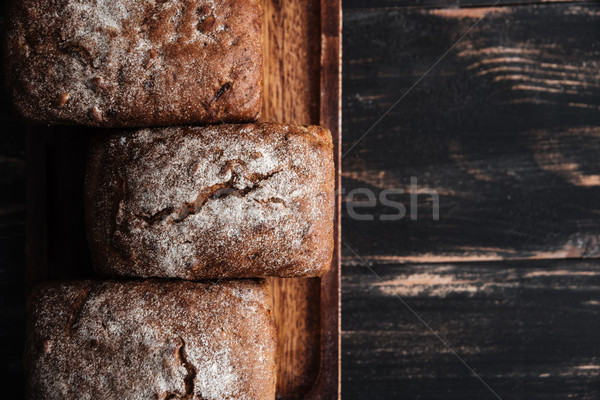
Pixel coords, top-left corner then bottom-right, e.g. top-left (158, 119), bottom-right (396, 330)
top-left (344, 0), bottom-right (590, 11)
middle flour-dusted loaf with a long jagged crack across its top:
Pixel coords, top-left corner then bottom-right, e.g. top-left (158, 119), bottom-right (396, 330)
top-left (86, 124), bottom-right (334, 279)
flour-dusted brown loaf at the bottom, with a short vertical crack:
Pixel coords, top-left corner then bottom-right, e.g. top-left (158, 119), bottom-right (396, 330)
top-left (26, 281), bottom-right (275, 400)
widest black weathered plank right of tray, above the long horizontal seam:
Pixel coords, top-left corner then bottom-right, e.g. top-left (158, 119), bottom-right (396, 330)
top-left (343, 3), bottom-right (600, 263)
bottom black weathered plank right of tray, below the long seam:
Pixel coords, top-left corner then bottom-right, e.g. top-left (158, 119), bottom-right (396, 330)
top-left (342, 260), bottom-right (600, 399)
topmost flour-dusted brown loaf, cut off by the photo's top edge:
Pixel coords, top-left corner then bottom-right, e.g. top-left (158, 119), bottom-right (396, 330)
top-left (5, 0), bottom-right (262, 127)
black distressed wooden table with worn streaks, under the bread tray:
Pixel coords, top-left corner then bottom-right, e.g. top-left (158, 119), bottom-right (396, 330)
top-left (0, 0), bottom-right (600, 399)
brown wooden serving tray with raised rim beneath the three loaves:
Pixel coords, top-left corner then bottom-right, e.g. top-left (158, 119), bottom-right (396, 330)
top-left (23, 0), bottom-right (341, 400)
